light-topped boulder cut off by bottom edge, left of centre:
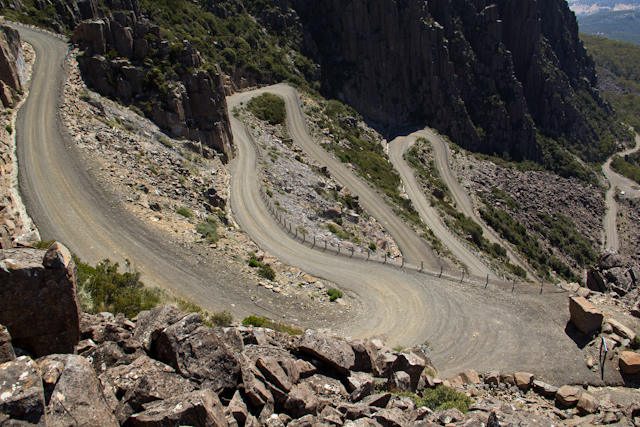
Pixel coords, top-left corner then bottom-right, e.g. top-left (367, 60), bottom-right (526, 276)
top-left (129, 389), bottom-right (227, 427)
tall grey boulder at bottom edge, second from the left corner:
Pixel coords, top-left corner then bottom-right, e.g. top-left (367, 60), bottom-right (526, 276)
top-left (38, 354), bottom-right (119, 427)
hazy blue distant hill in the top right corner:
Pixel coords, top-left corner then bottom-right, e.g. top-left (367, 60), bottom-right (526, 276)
top-left (578, 10), bottom-right (640, 45)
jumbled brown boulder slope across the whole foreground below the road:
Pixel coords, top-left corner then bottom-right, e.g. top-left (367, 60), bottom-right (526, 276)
top-left (0, 243), bottom-right (640, 427)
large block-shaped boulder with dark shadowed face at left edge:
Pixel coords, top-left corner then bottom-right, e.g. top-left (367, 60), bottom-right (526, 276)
top-left (0, 243), bottom-right (80, 357)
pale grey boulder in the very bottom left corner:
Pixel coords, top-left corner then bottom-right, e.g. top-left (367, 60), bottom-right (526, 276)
top-left (0, 356), bottom-right (48, 427)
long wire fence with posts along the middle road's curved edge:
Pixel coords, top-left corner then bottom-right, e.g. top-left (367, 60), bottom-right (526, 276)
top-left (245, 125), bottom-right (566, 294)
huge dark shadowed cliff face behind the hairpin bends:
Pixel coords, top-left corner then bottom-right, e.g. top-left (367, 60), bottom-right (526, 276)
top-left (293, 0), bottom-right (620, 159)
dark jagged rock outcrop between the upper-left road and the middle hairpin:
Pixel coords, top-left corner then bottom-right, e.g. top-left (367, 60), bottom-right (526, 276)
top-left (71, 11), bottom-right (233, 154)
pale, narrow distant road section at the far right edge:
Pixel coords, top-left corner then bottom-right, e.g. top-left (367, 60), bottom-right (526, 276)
top-left (602, 134), bottom-right (640, 249)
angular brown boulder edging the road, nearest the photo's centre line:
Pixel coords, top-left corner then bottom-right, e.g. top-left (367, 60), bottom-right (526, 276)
top-left (296, 329), bottom-right (355, 374)
